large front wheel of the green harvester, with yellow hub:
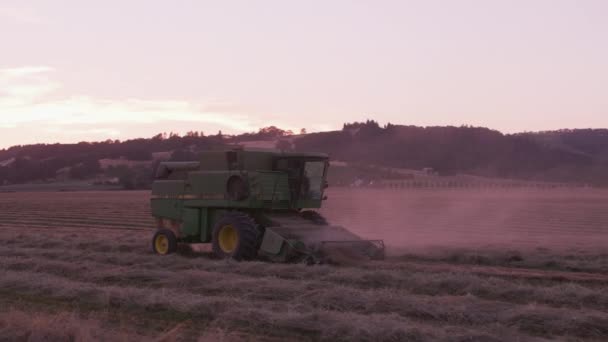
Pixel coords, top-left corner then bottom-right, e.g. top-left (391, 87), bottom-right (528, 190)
top-left (212, 211), bottom-right (260, 260)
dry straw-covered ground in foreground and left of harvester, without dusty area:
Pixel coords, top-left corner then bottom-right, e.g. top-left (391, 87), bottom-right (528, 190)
top-left (0, 193), bottom-right (608, 341)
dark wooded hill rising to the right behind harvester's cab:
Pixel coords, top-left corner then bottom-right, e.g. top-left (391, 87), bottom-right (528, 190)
top-left (296, 120), bottom-right (608, 185)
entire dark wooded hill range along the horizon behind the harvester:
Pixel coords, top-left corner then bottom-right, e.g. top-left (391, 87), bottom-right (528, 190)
top-left (0, 120), bottom-right (608, 188)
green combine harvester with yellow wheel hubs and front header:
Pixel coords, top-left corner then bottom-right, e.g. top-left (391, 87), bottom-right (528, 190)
top-left (151, 149), bottom-right (384, 264)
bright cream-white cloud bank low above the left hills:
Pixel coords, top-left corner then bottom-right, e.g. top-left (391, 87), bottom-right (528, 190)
top-left (0, 66), bottom-right (277, 146)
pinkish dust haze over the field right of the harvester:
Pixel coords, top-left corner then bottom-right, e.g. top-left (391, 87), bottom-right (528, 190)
top-left (321, 188), bottom-right (608, 255)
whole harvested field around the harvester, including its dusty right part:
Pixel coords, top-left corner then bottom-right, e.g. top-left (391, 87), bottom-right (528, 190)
top-left (0, 189), bottom-right (608, 341)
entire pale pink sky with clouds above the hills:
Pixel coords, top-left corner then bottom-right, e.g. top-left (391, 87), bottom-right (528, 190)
top-left (0, 0), bottom-right (608, 148)
